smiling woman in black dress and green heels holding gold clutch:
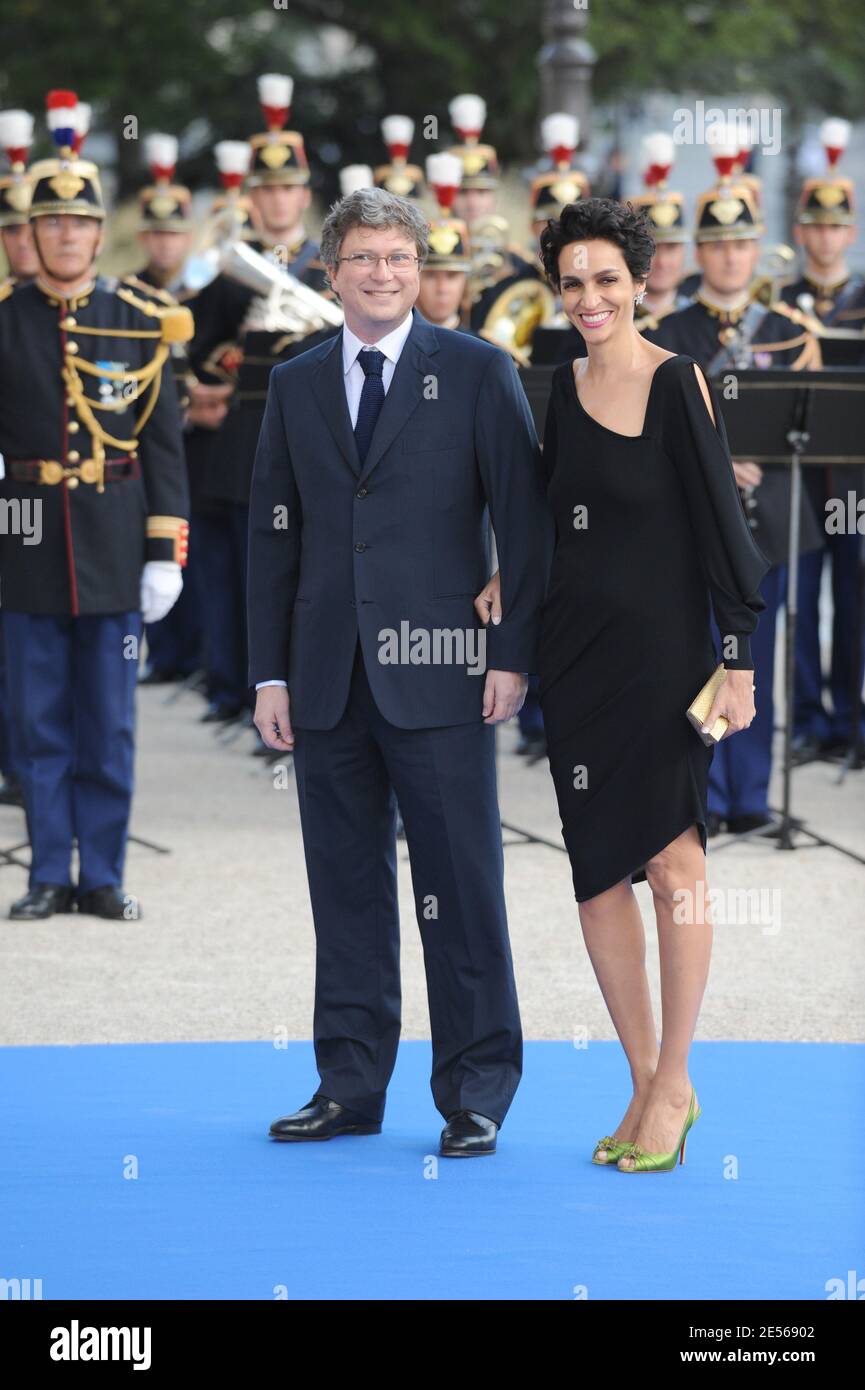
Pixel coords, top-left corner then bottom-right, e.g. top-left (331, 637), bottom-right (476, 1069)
top-left (478, 199), bottom-right (769, 1172)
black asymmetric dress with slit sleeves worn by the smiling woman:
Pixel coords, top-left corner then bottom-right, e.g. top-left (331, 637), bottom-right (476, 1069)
top-left (538, 353), bottom-right (769, 902)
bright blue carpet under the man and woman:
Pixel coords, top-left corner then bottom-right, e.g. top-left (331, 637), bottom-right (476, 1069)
top-left (0, 1043), bottom-right (865, 1300)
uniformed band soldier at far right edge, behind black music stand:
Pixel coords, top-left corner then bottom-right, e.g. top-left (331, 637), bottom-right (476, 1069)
top-left (782, 120), bottom-right (865, 762)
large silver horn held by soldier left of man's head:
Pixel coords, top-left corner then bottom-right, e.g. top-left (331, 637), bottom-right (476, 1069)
top-left (218, 239), bottom-right (343, 335)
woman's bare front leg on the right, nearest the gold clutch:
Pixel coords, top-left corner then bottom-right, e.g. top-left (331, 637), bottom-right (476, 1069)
top-left (623, 826), bottom-right (712, 1165)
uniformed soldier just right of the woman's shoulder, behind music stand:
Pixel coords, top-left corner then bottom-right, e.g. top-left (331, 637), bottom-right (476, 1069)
top-left (654, 135), bottom-right (820, 834)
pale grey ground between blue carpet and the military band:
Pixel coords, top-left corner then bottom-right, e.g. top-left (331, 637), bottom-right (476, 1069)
top-left (0, 656), bottom-right (865, 1045)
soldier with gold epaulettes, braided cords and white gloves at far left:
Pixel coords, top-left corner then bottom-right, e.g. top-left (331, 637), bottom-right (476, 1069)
top-left (0, 92), bottom-right (192, 919)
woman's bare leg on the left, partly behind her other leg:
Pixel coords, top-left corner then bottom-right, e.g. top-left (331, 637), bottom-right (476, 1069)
top-left (579, 877), bottom-right (658, 1156)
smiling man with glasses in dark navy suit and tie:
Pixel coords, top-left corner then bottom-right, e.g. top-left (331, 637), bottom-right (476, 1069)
top-left (249, 188), bottom-right (552, 1156)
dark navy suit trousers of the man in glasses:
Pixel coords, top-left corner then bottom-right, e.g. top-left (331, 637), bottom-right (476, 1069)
top-left (295, 642), bottom-right (523, 1125)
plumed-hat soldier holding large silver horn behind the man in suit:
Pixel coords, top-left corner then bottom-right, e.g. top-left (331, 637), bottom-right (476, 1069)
top-left (189, 74), bottom-right (342, 721)
